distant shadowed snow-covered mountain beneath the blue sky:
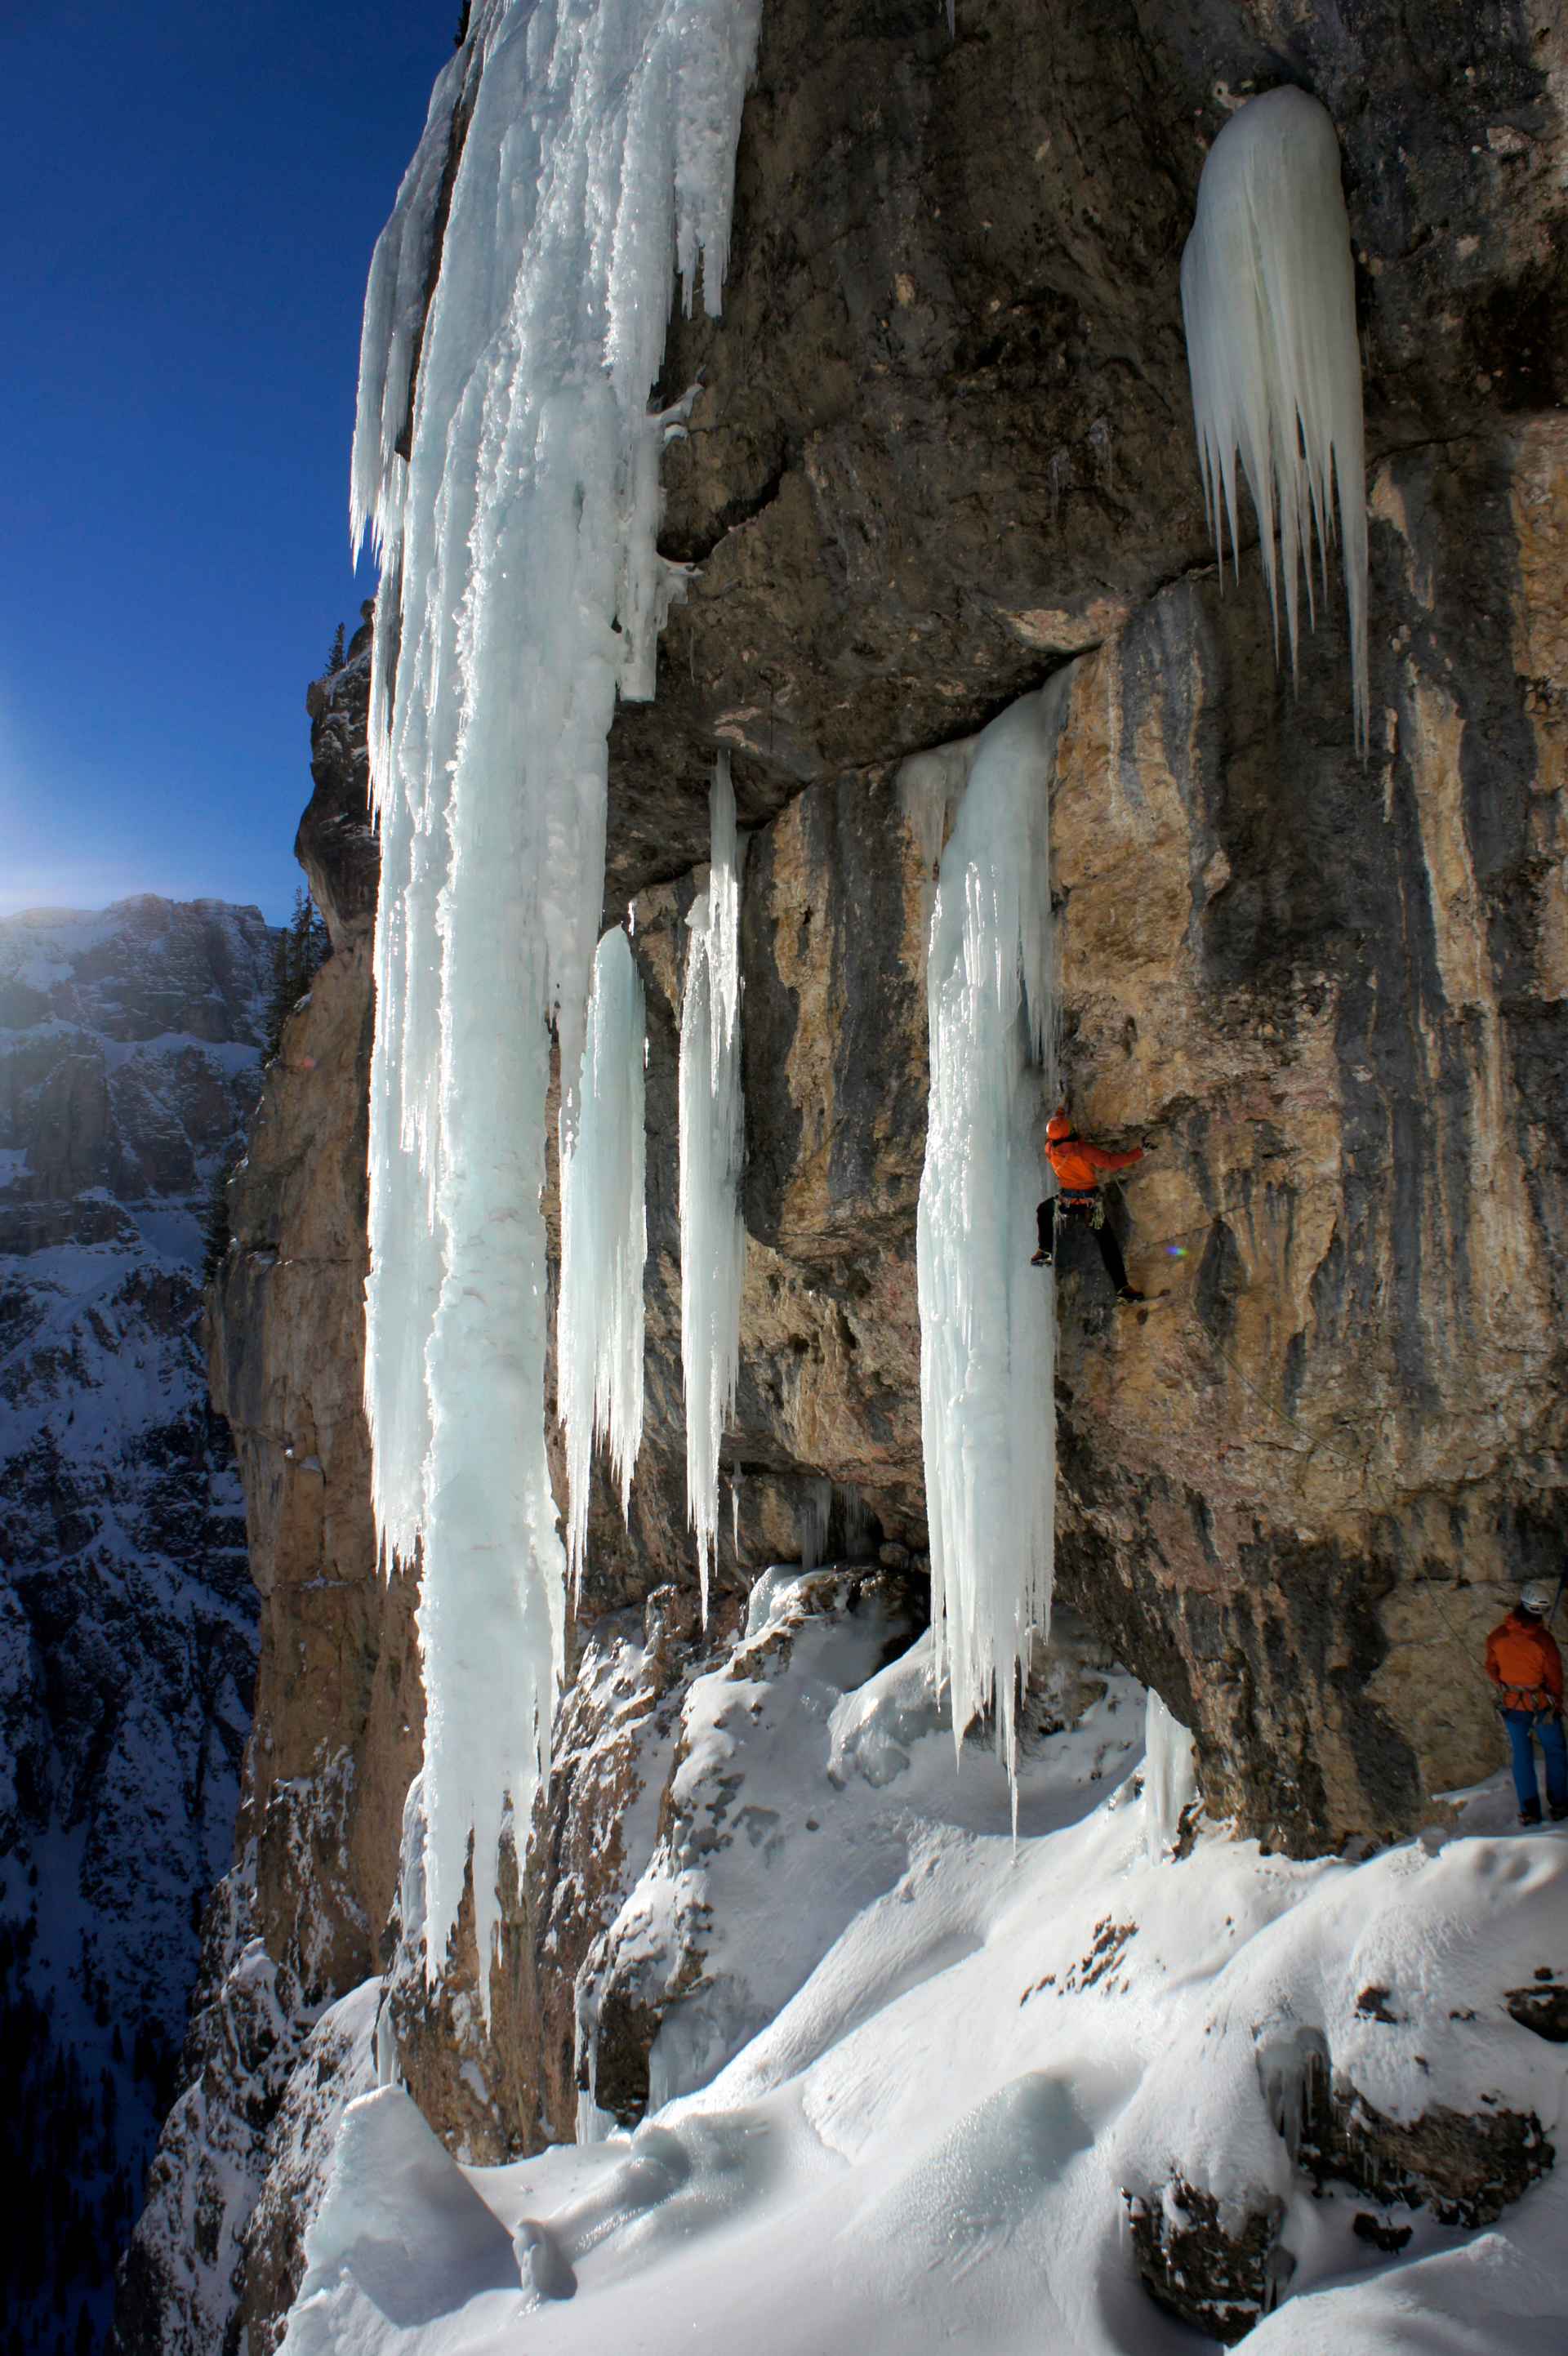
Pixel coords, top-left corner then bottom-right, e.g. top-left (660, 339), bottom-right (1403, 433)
top-left (0, 895), bottom-right (275, 2356)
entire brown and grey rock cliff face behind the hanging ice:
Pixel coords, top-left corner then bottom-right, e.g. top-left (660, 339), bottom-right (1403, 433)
top-left (139, 0), bottom-right (1568, 2349)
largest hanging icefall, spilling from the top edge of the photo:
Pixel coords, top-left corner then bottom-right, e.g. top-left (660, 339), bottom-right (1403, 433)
top-left (353, 0), bottom-right (760, 1997)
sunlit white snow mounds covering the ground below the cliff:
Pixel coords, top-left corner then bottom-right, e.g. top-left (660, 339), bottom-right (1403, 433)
top-left (283, 1574), bottom-right (1568, 2356)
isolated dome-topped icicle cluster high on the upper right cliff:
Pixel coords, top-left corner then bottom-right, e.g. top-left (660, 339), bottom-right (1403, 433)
top-left (1182, 87), bottom-right (1368, 751)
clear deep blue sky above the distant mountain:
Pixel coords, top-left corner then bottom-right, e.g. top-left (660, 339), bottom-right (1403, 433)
top-left (0, 0), bottom-right (459, 919)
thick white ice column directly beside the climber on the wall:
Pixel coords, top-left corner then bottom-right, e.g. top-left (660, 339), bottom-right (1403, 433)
top-left (914, 671), bottom-right (1071, 1760)
